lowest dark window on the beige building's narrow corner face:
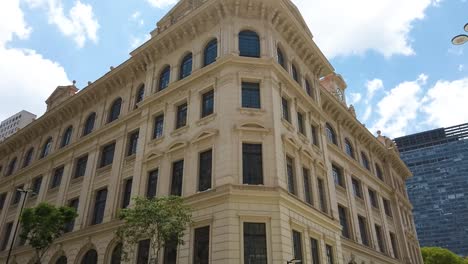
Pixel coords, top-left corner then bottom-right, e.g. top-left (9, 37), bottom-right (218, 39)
top-left (244, 223), bottom-right (268, 264)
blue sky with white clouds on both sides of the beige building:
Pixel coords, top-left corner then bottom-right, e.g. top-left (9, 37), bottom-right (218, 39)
top-left (0, 0), bottom-right (468, 137)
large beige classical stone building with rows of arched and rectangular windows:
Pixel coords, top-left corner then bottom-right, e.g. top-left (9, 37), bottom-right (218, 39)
top-left (0, 0), bottom-right (422, 264)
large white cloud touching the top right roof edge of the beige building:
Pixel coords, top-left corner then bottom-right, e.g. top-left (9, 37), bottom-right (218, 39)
top-left (293, 0), bottom-right (440, 58)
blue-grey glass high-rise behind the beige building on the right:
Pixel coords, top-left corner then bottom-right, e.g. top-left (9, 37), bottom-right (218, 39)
top-left (395, 123), bottom-right (468, 256)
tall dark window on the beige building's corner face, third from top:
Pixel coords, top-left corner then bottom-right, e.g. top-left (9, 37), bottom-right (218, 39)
top-left (242, 143), bottom-right (263, 185)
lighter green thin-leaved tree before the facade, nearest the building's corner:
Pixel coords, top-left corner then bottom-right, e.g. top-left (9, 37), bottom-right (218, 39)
top-left (117, 196), bottom-right (192, 264)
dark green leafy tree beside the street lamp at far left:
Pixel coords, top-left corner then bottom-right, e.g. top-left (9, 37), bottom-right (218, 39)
top-left (20, 203), bottom-right (77, 263)
